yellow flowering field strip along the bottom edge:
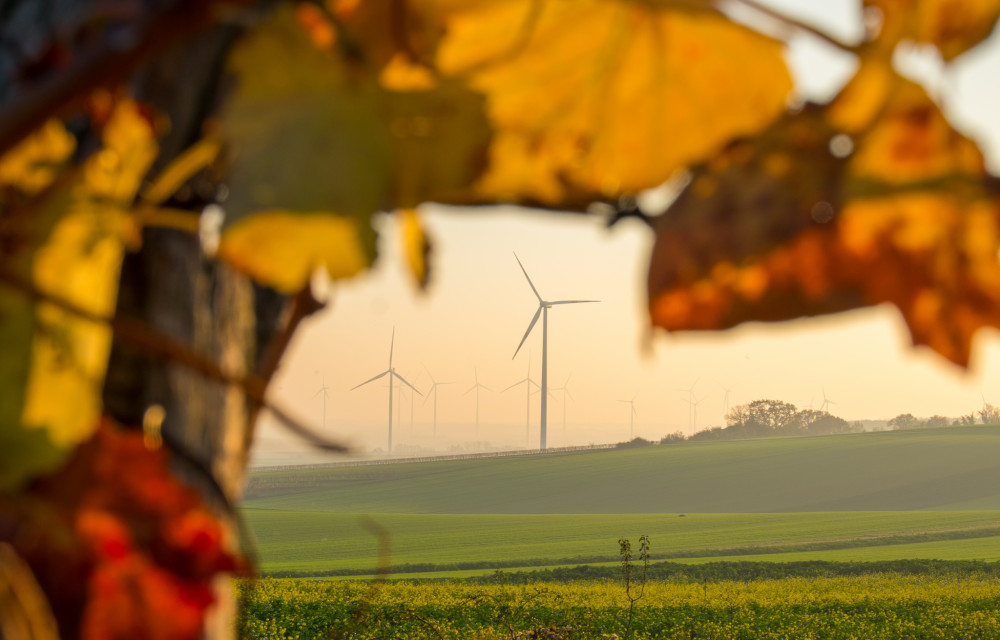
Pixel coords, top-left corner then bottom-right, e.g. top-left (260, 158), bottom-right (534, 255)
top-left (237, 574), bottom-right (1000, 640)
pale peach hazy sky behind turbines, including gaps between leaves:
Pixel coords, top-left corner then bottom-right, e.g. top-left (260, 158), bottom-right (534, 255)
top-left (252, 0), bottom-right (1000, 460)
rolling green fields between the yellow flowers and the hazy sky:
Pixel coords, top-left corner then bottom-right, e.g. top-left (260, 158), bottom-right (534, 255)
top-left (242, 427), bottom-right (1000, 575)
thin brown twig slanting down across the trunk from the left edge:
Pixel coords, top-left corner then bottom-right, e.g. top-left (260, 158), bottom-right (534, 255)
top-left (0, 266), bottom-right (349, 453)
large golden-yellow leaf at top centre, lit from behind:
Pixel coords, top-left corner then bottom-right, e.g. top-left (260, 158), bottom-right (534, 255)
top-left (438, 0), bottom-right (791, 206)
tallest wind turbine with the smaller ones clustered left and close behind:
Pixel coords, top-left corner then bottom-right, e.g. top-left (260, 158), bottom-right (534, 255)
top-left (344, 253), bottom-right (596, 454)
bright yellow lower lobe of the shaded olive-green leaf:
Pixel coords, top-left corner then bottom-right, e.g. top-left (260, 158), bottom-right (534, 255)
top-left (218, 211), bottom-right (371, 293)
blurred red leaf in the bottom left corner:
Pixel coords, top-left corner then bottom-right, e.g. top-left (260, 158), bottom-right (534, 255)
top-left (9, 422), bottom-right (240, 640)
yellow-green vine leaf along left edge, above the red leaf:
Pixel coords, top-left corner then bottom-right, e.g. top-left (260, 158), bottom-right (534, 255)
top-left (0, 100), bottom-right (157, 488)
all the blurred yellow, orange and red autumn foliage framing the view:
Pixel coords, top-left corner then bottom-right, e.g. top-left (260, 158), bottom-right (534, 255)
top-left (0, 0), bottom-right (1000, 638)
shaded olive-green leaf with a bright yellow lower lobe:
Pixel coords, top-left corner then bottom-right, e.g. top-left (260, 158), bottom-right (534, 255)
top-left (219, 4), bottom-right (489, 291)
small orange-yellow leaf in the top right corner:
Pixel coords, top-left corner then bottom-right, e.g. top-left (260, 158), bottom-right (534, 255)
top-left (865, 0), bottom-right (1000, 60)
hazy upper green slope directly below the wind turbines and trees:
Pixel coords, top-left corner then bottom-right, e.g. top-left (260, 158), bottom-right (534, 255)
top-left (245, 427), bottom-right (1000, 514)
